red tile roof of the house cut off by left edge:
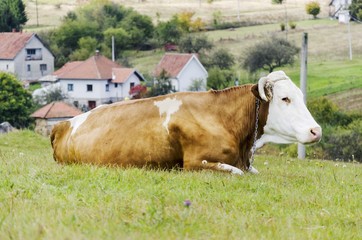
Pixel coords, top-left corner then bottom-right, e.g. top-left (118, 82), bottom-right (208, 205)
top-left (0, 32), bottom-right (35, 59)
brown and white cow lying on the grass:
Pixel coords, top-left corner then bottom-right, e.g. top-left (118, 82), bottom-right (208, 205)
top-left (51, 71), bottom-right (322, 175)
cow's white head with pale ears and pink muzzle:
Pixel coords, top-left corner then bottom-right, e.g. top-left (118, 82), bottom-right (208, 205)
top-left (253, 71), bottom-right (322, 147)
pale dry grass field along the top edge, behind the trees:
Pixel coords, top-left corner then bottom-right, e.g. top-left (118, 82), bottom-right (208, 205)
top-left (27, 0), bottom-right (330, 26)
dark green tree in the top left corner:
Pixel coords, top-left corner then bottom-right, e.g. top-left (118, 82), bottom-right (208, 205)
top-left (0, 0), bottom-right (28, 32)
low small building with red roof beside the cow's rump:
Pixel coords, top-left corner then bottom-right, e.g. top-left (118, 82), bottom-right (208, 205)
top-left (30, 102), bottom-right (82, 136)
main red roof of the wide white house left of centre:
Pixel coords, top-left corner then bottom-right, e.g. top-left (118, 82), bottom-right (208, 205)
top-left (53, 55), bottom-right (121, 80)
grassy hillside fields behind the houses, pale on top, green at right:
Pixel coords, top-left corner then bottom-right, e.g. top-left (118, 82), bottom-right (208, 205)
top-left (26, 0), bottom-right (362, 111)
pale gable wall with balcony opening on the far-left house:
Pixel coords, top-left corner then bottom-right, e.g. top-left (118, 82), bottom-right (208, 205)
top-left (14, 36), bottom-right (54, 80)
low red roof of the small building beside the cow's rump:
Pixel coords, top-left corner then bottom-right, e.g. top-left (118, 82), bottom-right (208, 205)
top-left (30, 102), bottom-right (82, 119)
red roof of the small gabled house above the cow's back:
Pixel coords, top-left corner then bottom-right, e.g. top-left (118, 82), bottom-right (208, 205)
top-left (154, 53), bottom-right (194, 77)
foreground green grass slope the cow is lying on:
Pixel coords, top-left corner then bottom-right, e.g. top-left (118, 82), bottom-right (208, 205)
top-left (0, 131), bottom-right (362, 240)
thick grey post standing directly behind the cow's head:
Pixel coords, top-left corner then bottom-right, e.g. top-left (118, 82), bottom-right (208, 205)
top-left (298, 33), bottom-right (308, 159)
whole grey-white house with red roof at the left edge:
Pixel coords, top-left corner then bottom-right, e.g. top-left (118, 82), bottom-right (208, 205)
top-left (0, 32), bottom-right (54, 81)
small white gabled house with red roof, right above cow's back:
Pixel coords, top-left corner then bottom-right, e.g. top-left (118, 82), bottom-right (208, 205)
top-left (154, 53), bottom-right (208, 92)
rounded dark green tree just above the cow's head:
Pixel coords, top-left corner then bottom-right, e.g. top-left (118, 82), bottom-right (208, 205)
top-left (242, 37), bottom-right (299, 73)
